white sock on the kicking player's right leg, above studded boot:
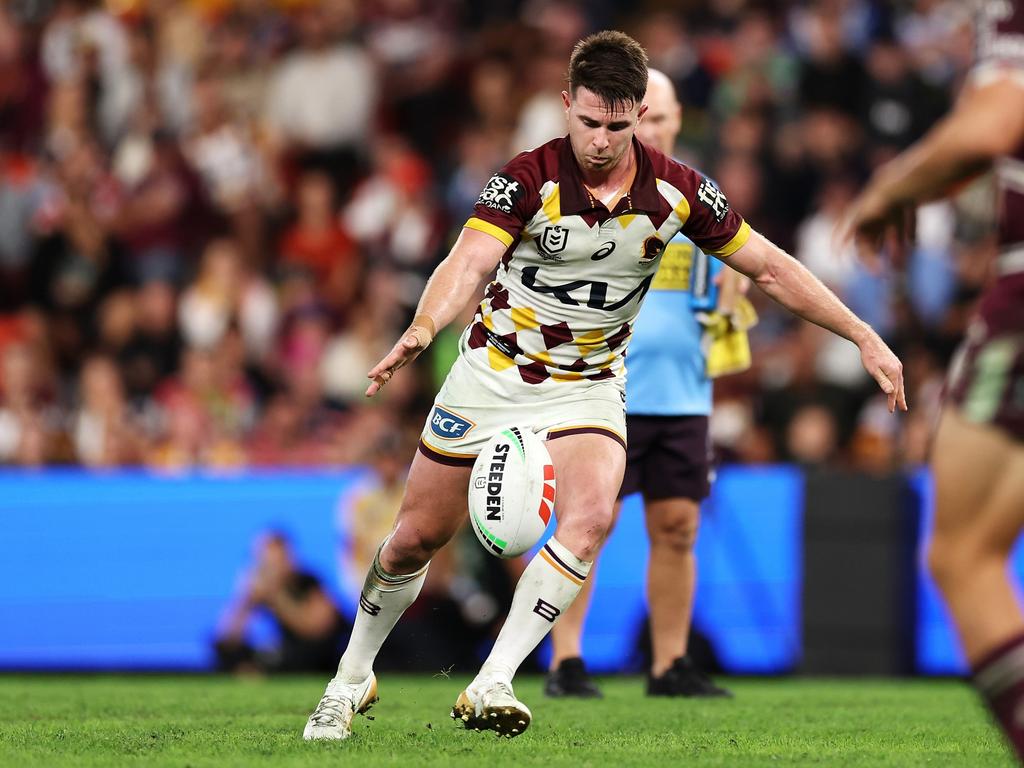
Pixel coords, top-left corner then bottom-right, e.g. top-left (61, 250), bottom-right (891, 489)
top-left (477, 538), bottom-right (594, 681)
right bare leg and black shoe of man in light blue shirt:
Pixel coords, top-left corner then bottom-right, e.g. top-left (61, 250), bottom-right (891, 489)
top-left (644, 498), bottom-right (729, 696)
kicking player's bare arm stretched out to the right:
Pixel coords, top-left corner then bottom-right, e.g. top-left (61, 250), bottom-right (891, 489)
top-left (726, 231), bottom-right (907, 413)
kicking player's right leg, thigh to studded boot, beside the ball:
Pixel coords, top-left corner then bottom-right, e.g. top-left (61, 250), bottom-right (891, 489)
top-left (452, 433), bottom-right (626, 736)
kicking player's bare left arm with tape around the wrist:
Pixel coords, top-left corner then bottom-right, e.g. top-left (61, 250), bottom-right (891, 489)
top-left (367, 227), bottom-right (507, 397)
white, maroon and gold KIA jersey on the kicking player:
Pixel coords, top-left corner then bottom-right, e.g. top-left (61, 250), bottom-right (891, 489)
top-left (463, 137), bottom-right (751, 384)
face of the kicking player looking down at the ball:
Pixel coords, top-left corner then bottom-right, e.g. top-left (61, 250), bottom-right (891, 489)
top-left (562, 87), bottom-right (647, 173)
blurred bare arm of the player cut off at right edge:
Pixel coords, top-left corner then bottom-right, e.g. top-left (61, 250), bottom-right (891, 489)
top-left (837, 71), bottom-right (1024, 249)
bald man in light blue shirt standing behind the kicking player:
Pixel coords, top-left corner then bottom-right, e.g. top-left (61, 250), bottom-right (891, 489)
top-left (545, 70), bottom-right (739, 697)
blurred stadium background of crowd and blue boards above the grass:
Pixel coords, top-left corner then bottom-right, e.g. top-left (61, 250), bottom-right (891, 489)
top-left (0, 0), bottom-right (1011, 674)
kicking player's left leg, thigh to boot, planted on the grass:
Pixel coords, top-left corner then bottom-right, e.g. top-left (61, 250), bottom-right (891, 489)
top-left (302, 454), bottom-right (470, 739)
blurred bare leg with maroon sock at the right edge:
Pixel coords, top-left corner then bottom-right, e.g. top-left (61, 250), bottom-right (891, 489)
top-left (928, 409), bottom-right (1024, 759)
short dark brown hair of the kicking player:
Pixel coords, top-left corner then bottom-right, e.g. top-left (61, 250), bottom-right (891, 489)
top-left (567, 30), bottom-right (647, 111)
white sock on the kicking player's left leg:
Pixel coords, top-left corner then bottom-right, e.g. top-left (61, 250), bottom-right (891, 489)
top-left (335, 539), bottom-right (429, 683)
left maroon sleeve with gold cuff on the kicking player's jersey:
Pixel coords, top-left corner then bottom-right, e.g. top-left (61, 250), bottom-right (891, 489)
top-left (465, 153), bottom-right (541, 248)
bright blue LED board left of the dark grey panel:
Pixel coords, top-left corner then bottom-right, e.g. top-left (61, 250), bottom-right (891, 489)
top-left (0, 468), bottom-right (802, 673)
